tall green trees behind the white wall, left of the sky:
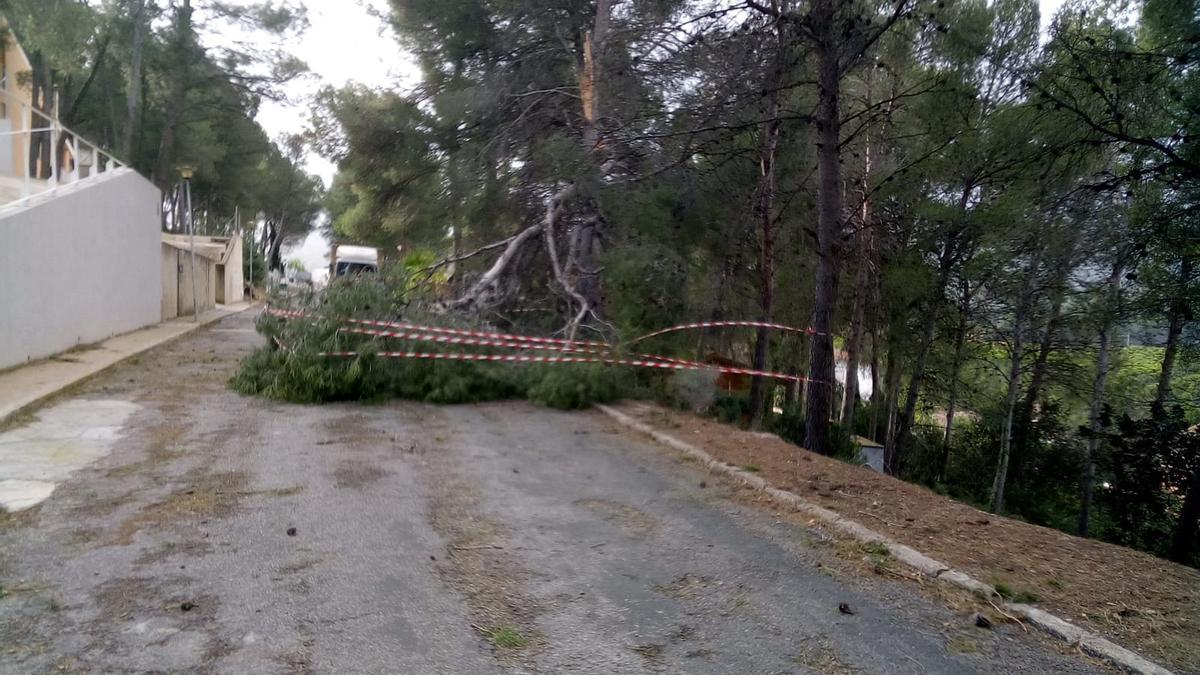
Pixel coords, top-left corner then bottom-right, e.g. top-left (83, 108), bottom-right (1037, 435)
top-left (0, 0), bottom-right (324, 268)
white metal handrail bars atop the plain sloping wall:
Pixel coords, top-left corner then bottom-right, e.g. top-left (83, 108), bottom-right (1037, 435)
top-left (0, 88), bottom-right (127, 205)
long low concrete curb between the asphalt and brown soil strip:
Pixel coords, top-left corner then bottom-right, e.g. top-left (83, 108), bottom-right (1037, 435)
top-left (596, 405), bottom-right (1172, 675)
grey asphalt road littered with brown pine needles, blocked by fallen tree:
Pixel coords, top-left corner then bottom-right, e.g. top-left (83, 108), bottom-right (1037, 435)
top-left (0, 312), bottom-right (1097, 674)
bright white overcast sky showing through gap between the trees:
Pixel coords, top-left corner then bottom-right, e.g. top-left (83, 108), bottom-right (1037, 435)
top-left (258, 0), bottom-right (1064, 270)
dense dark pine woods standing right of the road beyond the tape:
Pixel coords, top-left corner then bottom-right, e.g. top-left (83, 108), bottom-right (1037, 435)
top-left (316, 0), bottom-right (1200, 560)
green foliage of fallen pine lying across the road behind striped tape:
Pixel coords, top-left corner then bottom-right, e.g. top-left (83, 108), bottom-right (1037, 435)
top-left (230, 265), bottom-right (629, 410)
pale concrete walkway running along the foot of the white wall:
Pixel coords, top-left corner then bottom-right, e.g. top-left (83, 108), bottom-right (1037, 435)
top-left (0, 303), bottom-right (251, 424)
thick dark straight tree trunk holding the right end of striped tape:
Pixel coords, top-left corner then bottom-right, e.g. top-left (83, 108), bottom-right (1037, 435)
top-left (804, 0), bottom-right (841, 455)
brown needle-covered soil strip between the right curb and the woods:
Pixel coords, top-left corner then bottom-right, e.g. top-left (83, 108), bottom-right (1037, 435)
top-left (618, 396), bottom-right (1200, 673)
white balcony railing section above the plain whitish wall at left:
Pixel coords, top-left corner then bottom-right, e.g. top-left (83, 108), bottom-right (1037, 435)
top-left (0, 88), bottom-right (125, 205)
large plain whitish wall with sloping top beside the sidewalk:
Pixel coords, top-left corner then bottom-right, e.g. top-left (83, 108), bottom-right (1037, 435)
top-left (0, 169), bottom-right (162, 368)
